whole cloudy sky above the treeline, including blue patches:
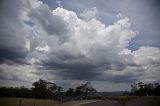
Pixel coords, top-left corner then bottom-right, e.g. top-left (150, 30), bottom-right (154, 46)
top-left (0, 0), bottom-right (160, 92)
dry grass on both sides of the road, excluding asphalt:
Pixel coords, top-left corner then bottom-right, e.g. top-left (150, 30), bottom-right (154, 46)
top-left (0, 96), bottom-right (160, 106)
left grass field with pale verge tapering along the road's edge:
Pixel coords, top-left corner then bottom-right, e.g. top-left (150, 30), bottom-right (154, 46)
top-left (0, 98), bottom-right (98, 106)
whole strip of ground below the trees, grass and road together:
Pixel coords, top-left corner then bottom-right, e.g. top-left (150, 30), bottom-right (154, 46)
top-left (0, 96), bottom-right (160, 106)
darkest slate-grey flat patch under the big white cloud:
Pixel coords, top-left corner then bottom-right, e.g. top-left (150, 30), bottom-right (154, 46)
top-left (43, 58), bottom-right (101, 80)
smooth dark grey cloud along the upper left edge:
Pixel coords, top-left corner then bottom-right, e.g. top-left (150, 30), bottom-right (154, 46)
top-left (0, 0), bottom-right (27, 62)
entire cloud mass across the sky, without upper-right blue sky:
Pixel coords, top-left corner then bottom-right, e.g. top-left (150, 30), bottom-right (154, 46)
top-left (0, 0), bottom-right (160, 90)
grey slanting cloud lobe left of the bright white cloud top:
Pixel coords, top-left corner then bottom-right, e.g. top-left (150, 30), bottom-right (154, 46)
top-left (29, 4), bottom-right (68, 36)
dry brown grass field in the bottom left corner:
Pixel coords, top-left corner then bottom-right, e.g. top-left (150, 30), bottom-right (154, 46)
top-left (0, 98), bottom-right (58, 106)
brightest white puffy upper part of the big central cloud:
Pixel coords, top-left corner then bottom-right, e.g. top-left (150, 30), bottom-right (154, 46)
top-left (45, 8), bottom-right (135, 64)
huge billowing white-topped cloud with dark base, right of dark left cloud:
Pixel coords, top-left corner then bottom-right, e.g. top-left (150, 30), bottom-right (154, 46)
top-left (0, 1), bottom-right (160, 87)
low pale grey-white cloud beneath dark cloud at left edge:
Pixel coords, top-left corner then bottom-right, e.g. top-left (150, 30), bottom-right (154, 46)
top-left (0, 63), bottom-right (40, 82)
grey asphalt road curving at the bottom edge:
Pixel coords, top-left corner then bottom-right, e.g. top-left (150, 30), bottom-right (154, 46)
top-left (79, 100), bottom-right (124, 106)
